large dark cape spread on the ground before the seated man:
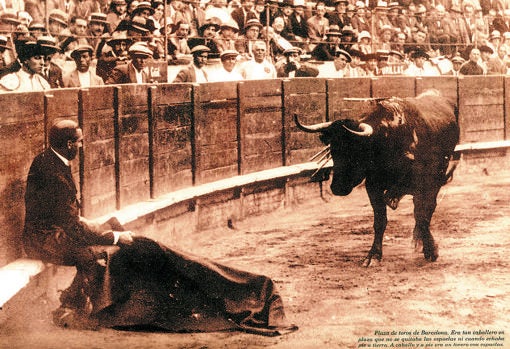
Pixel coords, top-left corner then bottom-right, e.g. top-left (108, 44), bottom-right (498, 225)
top-left (75, 237), bottom-right (297, 336)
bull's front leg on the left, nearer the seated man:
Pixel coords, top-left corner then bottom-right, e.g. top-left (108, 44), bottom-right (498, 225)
top-left (363, 183), bottom-right (388, 267)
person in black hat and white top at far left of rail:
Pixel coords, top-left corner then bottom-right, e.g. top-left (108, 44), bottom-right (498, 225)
top-left (0, 41), bottom-right (51, 92)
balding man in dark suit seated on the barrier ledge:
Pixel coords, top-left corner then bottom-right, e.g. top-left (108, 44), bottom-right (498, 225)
top-left (23, 120), bottom-right (133, 324)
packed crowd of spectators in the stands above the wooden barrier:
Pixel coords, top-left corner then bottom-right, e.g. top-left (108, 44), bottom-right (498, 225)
top-left (0, 0), bottom-right (510, 91)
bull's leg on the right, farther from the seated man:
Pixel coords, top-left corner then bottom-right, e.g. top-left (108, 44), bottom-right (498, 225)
top-left (413, 188), bottom-right (439, 262)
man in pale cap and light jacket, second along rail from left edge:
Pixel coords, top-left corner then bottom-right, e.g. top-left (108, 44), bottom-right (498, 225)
top-left (64, 45), bottom-right (104, 87)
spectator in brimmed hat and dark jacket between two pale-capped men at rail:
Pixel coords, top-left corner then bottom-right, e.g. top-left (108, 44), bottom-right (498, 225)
top-left (96, 32), bottom-right (131, 81)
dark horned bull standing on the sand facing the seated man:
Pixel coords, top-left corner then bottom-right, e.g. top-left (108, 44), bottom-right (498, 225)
top-left (294, 91), bottom-right (459, 266)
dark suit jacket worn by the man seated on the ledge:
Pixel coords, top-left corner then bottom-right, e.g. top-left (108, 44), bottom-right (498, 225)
top-left (23, 148), bottom-right (114, 265)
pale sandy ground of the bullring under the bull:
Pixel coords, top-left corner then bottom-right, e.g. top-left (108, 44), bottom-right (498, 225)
top-left (0, 173), bottom-right (510, 349)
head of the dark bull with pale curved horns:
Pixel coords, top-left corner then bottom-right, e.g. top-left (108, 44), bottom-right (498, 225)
top-left (294, 115), bottom-right (373, 196)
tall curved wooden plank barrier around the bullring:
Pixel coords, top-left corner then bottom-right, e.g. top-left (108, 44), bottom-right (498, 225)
top-left (0, 76), bottom-right (510, 266)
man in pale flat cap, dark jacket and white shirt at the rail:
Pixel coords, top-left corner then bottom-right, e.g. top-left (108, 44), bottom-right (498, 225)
top-left (105, 41), bottom-right (152, 84)
